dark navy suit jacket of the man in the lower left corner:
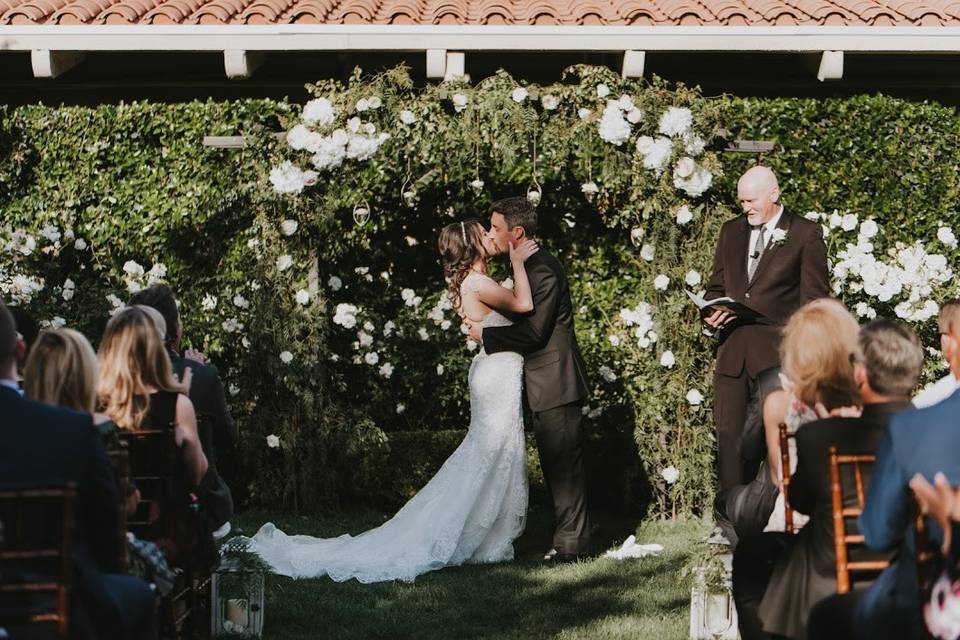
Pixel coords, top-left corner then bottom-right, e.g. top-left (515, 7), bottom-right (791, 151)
top-left (0, 386), bottom-right (123, 638)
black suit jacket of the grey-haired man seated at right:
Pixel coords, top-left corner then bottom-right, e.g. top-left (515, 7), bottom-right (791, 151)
top-left (760, 401), bottom-right (910, 638)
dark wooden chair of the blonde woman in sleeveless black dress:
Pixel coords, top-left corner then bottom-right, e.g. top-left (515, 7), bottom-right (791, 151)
top-left (120, 429), bottom-right (207, 639)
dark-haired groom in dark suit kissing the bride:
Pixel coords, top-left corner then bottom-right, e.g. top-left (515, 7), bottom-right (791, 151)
top-left (470, 197), bottom-right (590, 562)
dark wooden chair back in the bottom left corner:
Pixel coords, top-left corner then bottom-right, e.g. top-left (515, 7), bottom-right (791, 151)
top-left (0, 483), bottom-right (77, 639)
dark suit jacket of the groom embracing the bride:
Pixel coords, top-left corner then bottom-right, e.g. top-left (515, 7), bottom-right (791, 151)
top-left (483, 248), bottom-right (589, 411)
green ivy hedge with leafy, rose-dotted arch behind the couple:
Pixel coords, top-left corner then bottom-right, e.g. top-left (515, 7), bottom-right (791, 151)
top-left (0, 68), bottom-right (960, 515)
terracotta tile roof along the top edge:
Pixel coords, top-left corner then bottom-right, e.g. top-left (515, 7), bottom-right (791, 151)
top-left (0, 0), bottom-right (960, 27)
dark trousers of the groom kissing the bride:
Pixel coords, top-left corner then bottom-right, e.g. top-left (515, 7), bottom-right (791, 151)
top-left (533, 401), bottom-right (590, 554)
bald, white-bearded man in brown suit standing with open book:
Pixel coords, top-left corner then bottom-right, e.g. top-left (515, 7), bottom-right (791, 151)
top-left (703, 166), bottom-right (830, 489)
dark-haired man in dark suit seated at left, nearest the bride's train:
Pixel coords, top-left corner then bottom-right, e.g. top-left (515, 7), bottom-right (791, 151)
top-left (131, 284), bottom-right (237, 537)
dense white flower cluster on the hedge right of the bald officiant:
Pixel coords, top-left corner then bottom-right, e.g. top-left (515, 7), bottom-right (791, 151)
top-left (824, 212), bottom-right (953, 322)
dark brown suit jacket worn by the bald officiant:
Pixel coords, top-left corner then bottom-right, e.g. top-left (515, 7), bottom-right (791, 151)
top-left (706, 209), bottom-right (830, 377)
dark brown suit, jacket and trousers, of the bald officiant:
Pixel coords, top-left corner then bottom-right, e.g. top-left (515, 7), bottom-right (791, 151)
top-left (706, 211), bottom-right (830, 489)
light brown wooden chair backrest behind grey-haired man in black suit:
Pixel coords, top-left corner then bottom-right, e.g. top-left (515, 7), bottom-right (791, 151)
top-left (830, 447), bottom-right (890, 593)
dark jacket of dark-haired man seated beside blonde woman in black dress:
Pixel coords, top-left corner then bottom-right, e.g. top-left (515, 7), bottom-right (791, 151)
top-left (170, 350), bottom-right (238, 531)
